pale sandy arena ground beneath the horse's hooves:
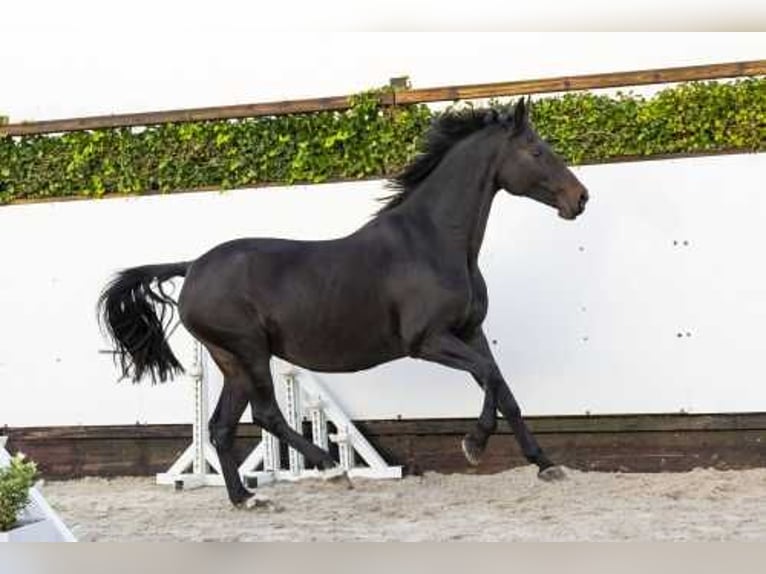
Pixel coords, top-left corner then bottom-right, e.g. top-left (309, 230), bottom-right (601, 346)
top-left (44, 467), bottom-right (766, 541)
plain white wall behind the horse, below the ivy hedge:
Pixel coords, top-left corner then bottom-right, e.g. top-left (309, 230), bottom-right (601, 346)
top-left (0, 154), bottom-right (766, 426)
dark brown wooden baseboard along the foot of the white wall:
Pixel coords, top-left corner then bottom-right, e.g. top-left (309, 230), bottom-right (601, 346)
top-left (0, 413), bottom-right (766, 478)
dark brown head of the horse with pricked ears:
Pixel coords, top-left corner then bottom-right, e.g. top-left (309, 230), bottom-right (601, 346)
top-left (497, 99), bottom-right (588, 219)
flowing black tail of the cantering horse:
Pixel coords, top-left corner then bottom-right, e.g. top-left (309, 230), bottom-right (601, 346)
top-left (97, 263), bottom-right (189, 383)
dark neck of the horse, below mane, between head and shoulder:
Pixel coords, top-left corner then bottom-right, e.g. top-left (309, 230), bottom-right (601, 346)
top-left (402, 141), bottom-right (497, 264)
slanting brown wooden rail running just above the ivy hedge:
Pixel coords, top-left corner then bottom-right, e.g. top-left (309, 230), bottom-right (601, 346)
top-left (0, 60), bottom-right (766, 136)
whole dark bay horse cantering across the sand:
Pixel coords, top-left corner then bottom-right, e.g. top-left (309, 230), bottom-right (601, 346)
top-left (99, 99), bottom-right (588, 505)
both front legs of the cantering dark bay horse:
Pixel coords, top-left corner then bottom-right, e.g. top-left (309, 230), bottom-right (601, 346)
top-left (417, 333), bottom-right (564, 480)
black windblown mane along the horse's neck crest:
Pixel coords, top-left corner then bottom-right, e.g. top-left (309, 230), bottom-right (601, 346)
top-left (378, 108), bottom-right (509, 213)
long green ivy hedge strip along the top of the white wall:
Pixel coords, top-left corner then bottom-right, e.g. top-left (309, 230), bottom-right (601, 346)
top-left (0, 78), bottom-right (766, 203)
